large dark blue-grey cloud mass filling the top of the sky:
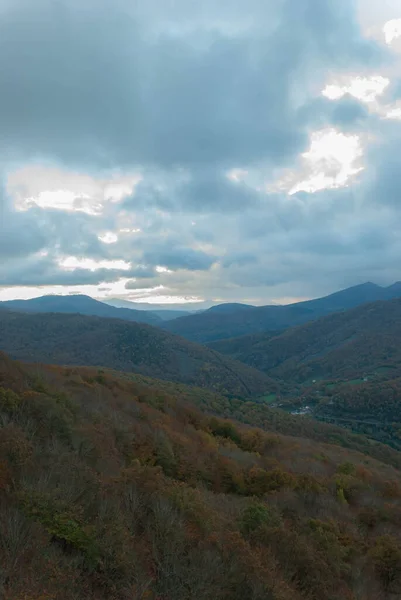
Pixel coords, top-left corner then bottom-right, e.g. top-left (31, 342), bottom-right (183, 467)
top-left (0, 0), bottom-right (380, 167)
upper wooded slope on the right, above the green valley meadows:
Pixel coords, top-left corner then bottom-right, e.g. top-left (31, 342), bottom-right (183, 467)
top-left (216, 299), bottom-right (401, 383)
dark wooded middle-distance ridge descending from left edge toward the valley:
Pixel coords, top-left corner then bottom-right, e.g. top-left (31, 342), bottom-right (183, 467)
top-left (0, 311), bottom-right (276, 397)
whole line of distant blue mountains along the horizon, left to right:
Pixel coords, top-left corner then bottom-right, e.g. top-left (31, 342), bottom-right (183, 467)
top-left (0, 282), bottom-right (401, 343)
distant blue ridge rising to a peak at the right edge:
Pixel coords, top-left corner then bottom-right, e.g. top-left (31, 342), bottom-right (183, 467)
top-left (163, 283), bottom-right (401, 343)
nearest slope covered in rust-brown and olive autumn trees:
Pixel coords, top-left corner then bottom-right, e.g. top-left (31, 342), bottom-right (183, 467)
top-left (0, 355), bottom-right (401, 600)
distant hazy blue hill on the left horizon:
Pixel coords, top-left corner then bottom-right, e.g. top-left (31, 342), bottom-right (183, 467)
top-left (0, 295), bottom-right (162, 325)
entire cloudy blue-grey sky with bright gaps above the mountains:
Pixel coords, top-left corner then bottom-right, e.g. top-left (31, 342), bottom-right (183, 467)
top-left (0, 0), bottom-right (401, 304)
